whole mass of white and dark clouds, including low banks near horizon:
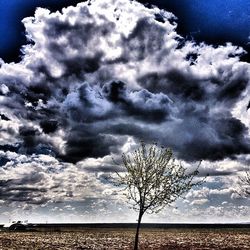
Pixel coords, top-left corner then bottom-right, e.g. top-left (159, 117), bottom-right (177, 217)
top-left (0, 0), bottom-right (250, 221)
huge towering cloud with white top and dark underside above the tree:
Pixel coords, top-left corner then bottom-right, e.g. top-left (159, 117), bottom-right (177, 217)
top-left (0, 0), bottom-right (250, 163)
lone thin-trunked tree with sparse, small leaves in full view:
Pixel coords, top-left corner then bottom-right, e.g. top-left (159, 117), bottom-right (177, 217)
top-left (117, 142), bottom-right (204, 250)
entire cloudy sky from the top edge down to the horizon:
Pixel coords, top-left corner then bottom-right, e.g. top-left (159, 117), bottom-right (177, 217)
top-left (0, 0), bottom-right (250, 223)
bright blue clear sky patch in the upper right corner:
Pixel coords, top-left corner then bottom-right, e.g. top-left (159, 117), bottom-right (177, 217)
top-left (142, 0), bottom-right (250, 50)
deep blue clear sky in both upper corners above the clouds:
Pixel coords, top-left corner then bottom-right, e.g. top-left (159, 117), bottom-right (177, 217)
top-left (0, 0), bottom-right (250, 61)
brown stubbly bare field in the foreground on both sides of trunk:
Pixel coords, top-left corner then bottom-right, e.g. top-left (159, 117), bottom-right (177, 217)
top-left (0, 229), bottom-right (250, 250)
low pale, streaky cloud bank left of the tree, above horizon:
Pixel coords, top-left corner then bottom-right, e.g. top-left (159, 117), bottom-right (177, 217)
top-left (0, 152), bottom-right (113, 206)
